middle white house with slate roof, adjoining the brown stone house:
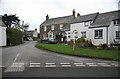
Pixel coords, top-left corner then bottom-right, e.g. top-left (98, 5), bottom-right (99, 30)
top-left (70, 13), bottom-right (99, 40)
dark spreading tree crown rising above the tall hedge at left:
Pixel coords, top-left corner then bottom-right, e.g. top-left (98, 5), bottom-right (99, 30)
top-left (2, 14), bottom-right (20, 28)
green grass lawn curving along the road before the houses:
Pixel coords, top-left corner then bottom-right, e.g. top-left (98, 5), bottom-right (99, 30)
top-left (36, 44), bottom-right (120, 60)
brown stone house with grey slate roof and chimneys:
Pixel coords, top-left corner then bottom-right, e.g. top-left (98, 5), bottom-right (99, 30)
top-left (40, 10), bottom-right (75, 42)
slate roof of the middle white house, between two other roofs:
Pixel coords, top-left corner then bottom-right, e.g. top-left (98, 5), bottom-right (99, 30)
top-left (72, 12), bottom-right (99, 23)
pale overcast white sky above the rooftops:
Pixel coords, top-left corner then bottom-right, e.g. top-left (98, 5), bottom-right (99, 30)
top-left (0, 0), bottom-right (119, 32)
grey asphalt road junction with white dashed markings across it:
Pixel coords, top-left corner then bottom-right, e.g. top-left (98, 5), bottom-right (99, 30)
top-left (2, 41), bottom-right (119, 77)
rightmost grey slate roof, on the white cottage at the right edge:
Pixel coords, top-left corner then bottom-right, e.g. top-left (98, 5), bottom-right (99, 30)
top-left (91, 10), bottom-right (120, 27)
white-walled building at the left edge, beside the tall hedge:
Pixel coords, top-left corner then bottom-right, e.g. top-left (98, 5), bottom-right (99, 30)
top-left (0, 16), bottom-right (7, 46)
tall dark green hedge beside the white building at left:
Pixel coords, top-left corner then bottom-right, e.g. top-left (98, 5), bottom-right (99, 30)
top-left (7, 28), bottom-right (22, 46)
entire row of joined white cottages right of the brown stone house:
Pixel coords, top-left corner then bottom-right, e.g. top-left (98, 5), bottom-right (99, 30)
top-left (70, 10), bottom-right (120, 45)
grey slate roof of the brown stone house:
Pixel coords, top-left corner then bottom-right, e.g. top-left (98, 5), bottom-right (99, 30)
top-left (41, 15), bottom-right (74, 26)
